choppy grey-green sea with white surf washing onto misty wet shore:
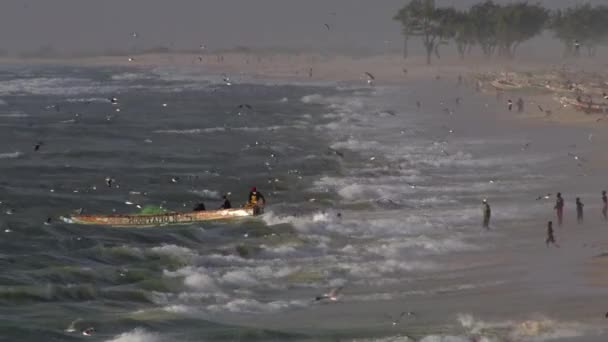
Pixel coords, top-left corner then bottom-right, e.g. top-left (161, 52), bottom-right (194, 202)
top-left (0, 66), bottom-right (608, 342)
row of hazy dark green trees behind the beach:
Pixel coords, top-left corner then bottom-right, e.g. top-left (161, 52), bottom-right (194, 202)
top-left (393, 0), bottom-right (608, 64)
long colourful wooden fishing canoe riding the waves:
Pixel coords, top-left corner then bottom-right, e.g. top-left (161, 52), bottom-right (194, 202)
top-left (61, 208), bottom-right (258, 227)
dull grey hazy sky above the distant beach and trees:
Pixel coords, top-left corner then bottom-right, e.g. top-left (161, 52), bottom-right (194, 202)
top-left (0, 0), bottom-right (608, 51)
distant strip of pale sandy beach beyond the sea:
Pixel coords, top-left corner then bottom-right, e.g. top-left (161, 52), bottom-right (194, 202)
top-left (0, 53), bottom-right (608, 126)
